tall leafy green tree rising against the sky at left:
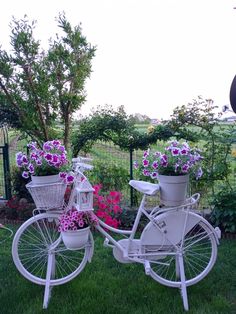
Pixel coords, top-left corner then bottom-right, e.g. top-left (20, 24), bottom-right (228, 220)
top-left (0, 14), bottom-right (95, 146)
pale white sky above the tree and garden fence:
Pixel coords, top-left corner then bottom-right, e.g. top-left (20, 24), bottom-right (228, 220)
top-left (0, 0), bottom-right (236, 119)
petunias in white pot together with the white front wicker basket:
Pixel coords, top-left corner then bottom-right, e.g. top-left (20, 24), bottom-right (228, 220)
top-left (16, 140), bottom-right (74, 209)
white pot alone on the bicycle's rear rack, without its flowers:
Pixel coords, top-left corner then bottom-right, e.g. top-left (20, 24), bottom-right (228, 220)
top-left (158, 174), bottom-right (189, 206)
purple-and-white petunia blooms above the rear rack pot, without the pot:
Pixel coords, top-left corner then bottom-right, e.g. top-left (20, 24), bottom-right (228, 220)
top-left (134, 140), bottom-right (203, 179)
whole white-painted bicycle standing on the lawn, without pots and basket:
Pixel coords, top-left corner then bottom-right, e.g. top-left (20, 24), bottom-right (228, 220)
top-left (12, 158), bottom-right (220, 310)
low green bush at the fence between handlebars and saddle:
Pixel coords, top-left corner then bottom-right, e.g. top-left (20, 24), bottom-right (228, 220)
top-left (87, 161), bottom-right (129, 191)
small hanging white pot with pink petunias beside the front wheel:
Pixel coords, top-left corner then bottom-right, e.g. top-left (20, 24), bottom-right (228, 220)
top-left (58, 207), bottom-right (98, 250)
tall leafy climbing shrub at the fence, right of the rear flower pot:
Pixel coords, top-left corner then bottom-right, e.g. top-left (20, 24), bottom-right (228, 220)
top-left (168, 97), bottom-right (236, 195)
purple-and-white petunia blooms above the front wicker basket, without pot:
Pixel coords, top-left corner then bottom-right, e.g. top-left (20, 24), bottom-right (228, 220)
top-left (16, 140), bottom-right (74, 183)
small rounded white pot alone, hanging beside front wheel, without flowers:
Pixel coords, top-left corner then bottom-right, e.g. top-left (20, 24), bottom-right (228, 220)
top-left (61, 227), bottom-right (90, 250)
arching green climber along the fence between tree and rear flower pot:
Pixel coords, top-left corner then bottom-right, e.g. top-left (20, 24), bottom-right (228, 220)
top-left (72, 106), bottom-right (173, 156)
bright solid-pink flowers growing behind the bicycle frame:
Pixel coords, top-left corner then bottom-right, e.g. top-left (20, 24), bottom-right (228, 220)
top-left (93, 184), bottom-right (122, 228)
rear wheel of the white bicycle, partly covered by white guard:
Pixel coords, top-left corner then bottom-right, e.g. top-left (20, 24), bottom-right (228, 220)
top-left (142, 213), bottom-right (217, 287)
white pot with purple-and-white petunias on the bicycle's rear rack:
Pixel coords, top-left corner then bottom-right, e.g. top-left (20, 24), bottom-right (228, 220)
top-left (134, 140), bottom-right (203, 206)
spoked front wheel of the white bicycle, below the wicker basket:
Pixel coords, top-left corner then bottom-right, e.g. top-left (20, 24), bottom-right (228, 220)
top-left (12, 213), bottom-right (93, 286)
